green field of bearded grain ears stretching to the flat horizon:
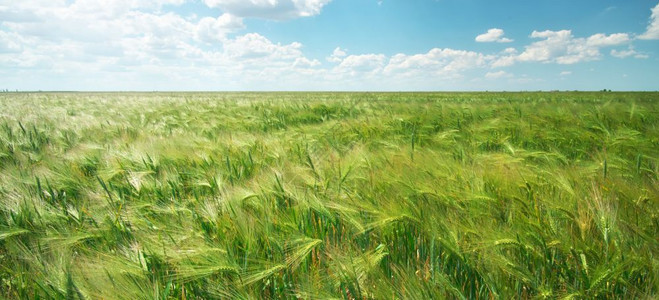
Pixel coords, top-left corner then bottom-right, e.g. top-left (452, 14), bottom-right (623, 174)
top-left (0, 92), bottom-right (659, 299)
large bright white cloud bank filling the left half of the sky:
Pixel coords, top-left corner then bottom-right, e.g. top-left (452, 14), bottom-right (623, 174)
top-left (0, 0), bottom-right (328, 89)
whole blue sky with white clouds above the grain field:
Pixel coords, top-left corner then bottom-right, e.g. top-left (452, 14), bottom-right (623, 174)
top-left (0, 0), bottom-right (659, 91)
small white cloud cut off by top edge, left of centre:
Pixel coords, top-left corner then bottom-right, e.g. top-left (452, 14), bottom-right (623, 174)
top-left (203, 0), bottom-right (332, 20)
